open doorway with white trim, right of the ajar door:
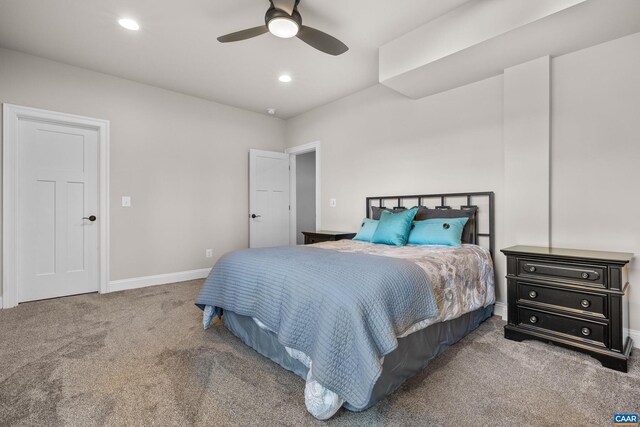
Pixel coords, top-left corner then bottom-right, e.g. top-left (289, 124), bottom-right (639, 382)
top-left (286, 141), bottom-right (320, 245)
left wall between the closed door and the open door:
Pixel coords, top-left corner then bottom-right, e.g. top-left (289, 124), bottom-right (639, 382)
top-left (0, 49), bottom-right (284, 288)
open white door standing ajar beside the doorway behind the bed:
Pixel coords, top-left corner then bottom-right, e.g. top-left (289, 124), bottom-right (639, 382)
top-left (249, 150), bottom-right (289, 248)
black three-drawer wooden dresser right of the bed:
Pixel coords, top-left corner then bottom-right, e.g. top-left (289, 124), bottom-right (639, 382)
top-left (502, 246), bottom-right (633, 372)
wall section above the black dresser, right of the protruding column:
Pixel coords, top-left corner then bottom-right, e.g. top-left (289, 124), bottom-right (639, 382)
top-left (551, 33), bottom-right (640, 328)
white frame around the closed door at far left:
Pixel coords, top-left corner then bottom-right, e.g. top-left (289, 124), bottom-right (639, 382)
top-left (2, 104), bottom-right (109, 308)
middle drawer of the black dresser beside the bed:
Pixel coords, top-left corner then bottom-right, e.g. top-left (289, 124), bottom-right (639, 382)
top-left (518, 282), bottom-right (608, 318)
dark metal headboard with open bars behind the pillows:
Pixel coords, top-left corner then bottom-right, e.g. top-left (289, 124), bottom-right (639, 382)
top-left (367, 191), bottom-right (495, 257)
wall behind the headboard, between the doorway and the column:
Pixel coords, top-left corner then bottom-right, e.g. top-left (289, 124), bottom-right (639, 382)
top-left (286, 76), bottom-right (504, 298)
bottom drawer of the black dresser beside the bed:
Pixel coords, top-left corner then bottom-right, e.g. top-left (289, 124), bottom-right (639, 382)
top-left (518, 307), bottom-right (609, 347)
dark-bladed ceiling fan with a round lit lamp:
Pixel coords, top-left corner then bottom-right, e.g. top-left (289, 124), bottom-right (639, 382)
top-left (218, 0), bottom-right (349, 56)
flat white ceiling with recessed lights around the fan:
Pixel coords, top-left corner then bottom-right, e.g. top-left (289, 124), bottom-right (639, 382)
top-left (0, 0), bottom-right (468, 118)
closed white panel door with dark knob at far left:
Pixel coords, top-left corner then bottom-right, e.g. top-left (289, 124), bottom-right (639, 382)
top-left (17, 120), bottom-right (100, 302)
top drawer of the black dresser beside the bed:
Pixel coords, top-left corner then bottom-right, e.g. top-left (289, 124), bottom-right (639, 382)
top-left (518, 259), bottom-right (607, 287)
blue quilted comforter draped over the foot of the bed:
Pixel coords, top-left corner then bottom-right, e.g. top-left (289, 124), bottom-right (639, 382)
top-left (196, 246), bottom-right (438, 408)
